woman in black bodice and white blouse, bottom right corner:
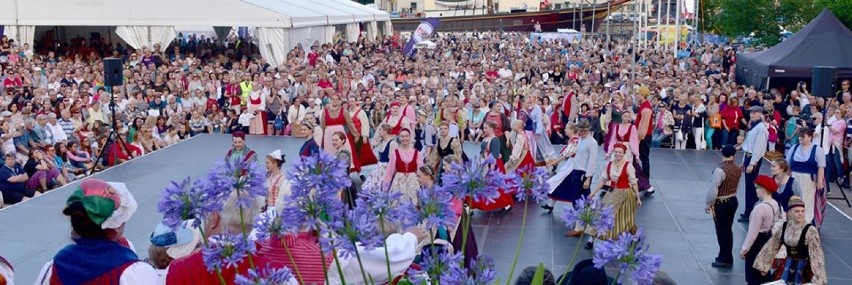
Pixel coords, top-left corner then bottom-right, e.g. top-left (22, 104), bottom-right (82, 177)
top-left (746, 196), bottom-right (828, 285)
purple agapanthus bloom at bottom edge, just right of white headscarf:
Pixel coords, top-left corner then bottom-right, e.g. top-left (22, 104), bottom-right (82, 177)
top-left (408, 247), bottom-right (467, 285)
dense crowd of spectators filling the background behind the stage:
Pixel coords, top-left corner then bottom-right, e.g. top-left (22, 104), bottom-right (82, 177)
top-left (0, 29), bottom-right (852, 209)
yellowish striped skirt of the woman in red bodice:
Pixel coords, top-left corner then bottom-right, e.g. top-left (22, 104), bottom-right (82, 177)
top-left (598, 189), bottom-right (636, 240)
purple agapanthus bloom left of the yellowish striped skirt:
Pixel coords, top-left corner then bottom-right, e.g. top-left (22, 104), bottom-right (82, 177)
top-left (560, 197), bottom-right (615, 234)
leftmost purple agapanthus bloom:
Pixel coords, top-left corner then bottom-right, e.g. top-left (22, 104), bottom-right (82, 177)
top-left (157, 177), bottom-right (229, 229)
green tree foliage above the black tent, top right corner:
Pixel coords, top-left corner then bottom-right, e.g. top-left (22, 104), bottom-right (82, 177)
top-left (701, 0), bottom-right (852, 46)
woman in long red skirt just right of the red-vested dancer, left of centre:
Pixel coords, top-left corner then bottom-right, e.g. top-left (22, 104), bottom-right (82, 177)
top-left (344, 96), bottom-right (378, 172)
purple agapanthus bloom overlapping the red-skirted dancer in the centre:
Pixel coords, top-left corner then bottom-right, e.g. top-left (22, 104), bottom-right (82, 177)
top-left (441, 156), bottom-right (507, 203)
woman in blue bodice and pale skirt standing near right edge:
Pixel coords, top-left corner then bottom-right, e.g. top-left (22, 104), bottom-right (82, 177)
top-left (786, 128), bottom-right (826, 229)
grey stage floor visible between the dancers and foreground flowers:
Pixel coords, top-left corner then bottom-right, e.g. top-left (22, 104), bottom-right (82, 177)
top-left (0, 135), bottom-right (852, 285)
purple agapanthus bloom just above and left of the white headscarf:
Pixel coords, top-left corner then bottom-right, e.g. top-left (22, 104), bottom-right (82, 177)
top-left (332, 205), bottom-right (383, 258)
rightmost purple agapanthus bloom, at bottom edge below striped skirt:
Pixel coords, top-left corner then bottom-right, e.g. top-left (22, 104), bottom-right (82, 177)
top-left (593, 230), bottom-right (663, 285)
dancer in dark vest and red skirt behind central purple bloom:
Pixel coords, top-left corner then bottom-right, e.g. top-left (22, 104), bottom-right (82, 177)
top-left (467, 121), bottom-right (515, 211)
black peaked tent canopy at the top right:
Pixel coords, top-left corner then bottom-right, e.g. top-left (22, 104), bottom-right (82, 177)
top-left (736, 9), bottom-right (852, 88)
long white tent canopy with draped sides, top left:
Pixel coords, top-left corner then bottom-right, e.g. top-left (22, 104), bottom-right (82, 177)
top-left (0, 0), bottom-right (390, 64)
